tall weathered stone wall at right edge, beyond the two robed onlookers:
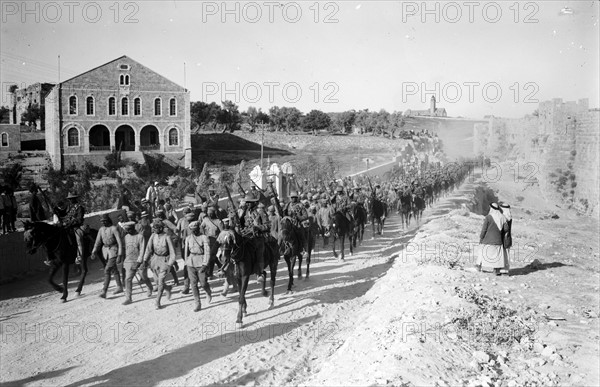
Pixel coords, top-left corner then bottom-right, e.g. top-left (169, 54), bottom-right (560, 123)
top-left (473, 98), bottom-right (600, 214)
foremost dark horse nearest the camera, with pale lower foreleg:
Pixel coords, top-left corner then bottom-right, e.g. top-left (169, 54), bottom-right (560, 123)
top-left (231, 232), bottom-right (279, 328)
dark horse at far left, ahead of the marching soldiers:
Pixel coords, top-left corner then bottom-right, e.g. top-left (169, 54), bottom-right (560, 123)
top-left (24, 222), bottom-right (91, 302)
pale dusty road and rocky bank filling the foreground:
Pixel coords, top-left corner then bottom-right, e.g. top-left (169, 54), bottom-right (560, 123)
top-left (0, 157), bottom-right (600, 386)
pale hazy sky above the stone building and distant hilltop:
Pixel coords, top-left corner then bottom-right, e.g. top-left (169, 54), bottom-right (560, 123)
top-left (0, 0), bottom-right (600, 118)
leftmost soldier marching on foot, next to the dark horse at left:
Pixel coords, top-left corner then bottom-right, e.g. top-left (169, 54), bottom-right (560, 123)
top-left (92, 214), bottom-right (123, 298)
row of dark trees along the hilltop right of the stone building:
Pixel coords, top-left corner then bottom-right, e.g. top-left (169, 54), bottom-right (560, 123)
top-left (190, 101), bottom-right (405, 138)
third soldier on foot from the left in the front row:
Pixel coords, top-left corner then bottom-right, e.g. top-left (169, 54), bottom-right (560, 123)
top-left (144, 219), bottom-right (176, 309)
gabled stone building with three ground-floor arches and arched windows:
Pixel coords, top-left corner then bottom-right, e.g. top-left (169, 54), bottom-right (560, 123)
top-left (45, 55), bottom-right (192, 168)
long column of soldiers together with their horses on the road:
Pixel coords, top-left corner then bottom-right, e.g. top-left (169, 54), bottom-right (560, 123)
top-left (26, 159), bottom-right (470, 323)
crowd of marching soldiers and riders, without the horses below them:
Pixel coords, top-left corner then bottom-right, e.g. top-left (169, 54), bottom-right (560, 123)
top-left (92, 163), bottom-right (472, 311)
